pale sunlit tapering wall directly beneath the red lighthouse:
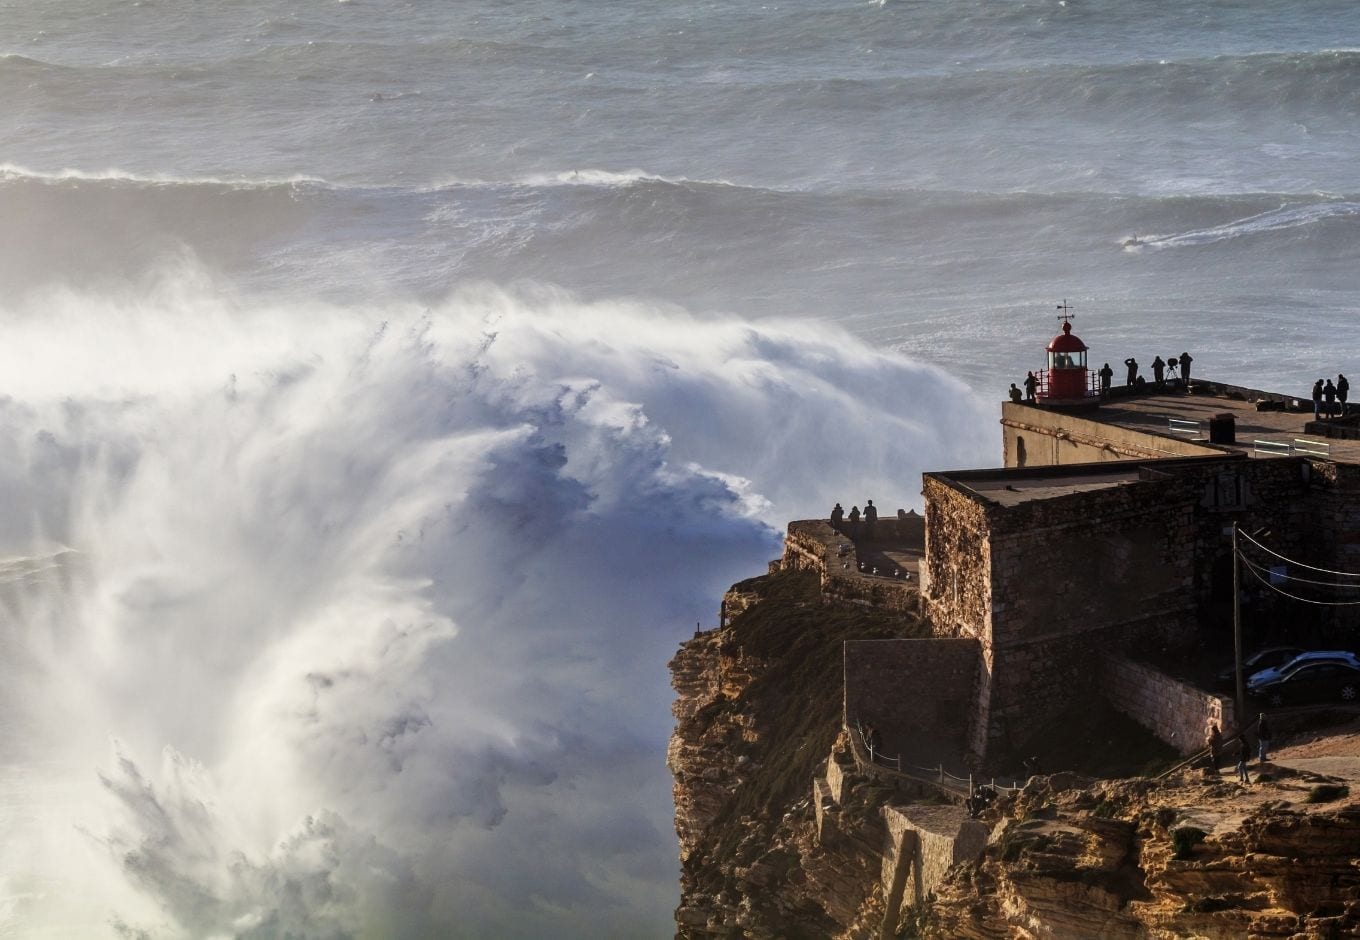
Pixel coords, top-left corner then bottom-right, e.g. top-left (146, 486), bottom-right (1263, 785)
top-left (1001, 401), bottom-right (1223, 467)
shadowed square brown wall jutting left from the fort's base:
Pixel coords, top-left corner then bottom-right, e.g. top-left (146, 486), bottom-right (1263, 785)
top-left (843, 638), bottom-right (978, 765)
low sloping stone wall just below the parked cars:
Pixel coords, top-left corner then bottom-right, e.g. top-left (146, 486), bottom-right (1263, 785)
top-left (1102, 653), bottom-right (1235, 754)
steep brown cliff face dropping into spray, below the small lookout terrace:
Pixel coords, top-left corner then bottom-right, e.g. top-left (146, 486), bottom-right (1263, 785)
top-left (668, 573), bottom-right (919, 939)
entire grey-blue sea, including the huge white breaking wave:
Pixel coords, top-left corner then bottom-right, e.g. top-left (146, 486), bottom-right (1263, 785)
top-left (0, 0), bottom-right (1360, 937)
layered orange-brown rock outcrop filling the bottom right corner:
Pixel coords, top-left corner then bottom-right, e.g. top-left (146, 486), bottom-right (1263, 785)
top-left (922, 773), bottom-right (1360, 940)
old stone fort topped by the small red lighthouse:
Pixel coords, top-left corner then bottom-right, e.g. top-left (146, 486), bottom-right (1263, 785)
top-left (782, 322), bottom-right (1360, 769)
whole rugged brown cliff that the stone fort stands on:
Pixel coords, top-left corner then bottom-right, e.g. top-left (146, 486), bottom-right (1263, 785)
top-left (669, 571), bottom-right (1360, 940)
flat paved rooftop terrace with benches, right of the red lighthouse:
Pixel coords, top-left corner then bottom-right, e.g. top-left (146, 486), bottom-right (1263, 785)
top-left (1081, 392), bottom-right (1360, 464)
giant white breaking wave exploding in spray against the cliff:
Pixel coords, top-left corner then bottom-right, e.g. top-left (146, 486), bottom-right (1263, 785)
top-left (0, 271), bottom-right (991, 937)
